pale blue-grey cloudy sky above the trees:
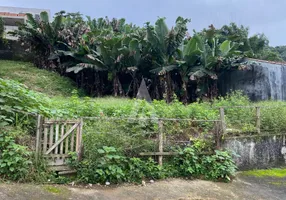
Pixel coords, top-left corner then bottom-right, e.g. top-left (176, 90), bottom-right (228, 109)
top-left (0, 0), bottom-right (286, 46)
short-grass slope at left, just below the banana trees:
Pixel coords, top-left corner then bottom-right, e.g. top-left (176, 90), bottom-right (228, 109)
top-left (0, 60), bottom-right (79, 97)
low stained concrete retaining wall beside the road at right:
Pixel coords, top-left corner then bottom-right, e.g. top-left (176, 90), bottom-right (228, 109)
top-left (223, 134), bottom-right (286, 170)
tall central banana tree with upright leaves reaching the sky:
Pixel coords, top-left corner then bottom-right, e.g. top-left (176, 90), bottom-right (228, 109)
top-left (146, 17), bottom-right (190, 102)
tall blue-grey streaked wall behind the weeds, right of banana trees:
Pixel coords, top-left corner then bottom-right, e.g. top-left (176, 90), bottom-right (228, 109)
top-left (218, 59), bottom-right (286, 101)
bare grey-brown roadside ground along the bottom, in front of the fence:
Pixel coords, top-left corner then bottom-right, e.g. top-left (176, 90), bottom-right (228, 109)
top-left (0, 174), bottom-right (286, 200)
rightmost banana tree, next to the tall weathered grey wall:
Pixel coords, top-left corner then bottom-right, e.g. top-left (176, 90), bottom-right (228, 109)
top-left (189, 32), bottom-right (242, 98)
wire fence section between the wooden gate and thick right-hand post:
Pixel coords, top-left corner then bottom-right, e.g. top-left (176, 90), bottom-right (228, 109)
top-left (83, 117), bottom-right (221, 162)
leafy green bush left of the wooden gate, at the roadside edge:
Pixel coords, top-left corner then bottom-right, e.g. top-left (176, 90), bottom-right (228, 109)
top-left (0, 132), bottom-right (31, 180)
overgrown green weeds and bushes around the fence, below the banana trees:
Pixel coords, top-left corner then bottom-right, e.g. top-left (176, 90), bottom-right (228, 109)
top-left (0, 76), bottom-right (286, 183)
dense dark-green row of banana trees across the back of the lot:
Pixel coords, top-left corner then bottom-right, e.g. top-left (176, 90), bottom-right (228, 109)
top-left (9, 11), bottom-right (282, 103)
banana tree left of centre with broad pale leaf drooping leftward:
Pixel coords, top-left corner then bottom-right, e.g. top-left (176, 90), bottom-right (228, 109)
top-left (60, 31), bottom-right (140, 96)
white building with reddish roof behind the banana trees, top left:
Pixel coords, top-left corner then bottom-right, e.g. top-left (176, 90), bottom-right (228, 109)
top-left (0, 6), bottom-right (51, 39)
